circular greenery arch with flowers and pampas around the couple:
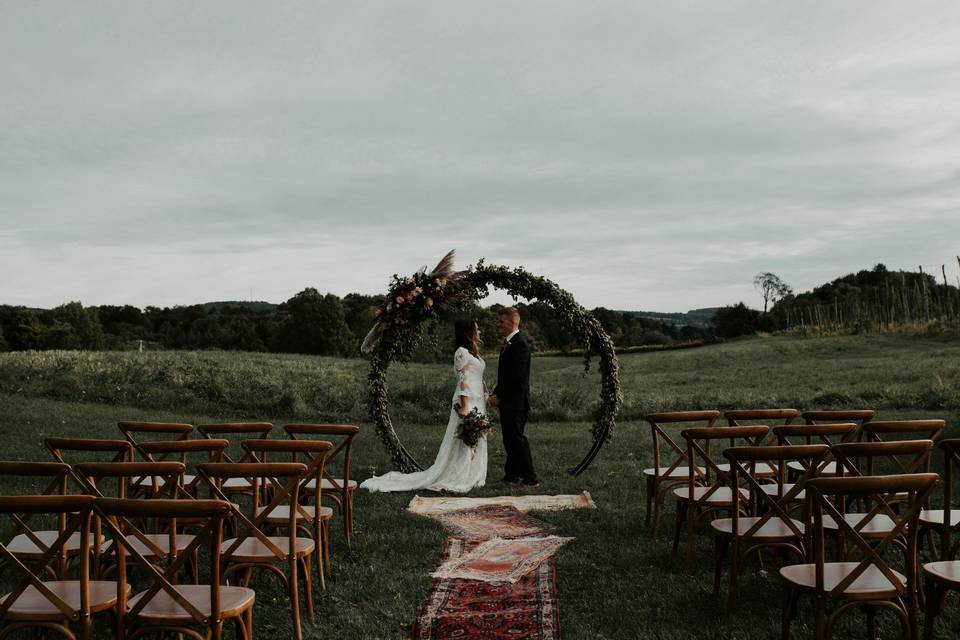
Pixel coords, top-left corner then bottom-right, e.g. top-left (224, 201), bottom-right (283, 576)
top-left (363, 251), bottom-right (622, 475)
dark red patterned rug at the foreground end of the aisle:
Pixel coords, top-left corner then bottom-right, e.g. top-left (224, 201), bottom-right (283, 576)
top-left (413, 538), bottom-right (560, 640)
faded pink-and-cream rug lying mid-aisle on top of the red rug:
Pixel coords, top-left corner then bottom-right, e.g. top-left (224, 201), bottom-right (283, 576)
top-left (430, 536), bottom-right (573, 584)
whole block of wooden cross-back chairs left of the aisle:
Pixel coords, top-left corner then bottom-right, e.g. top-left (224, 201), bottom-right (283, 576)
top-left (0, 423), bottom-right (358, 638)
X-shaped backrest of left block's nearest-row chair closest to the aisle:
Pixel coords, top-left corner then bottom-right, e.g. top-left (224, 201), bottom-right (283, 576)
top-left (94, 498), bottom-right (231, 637)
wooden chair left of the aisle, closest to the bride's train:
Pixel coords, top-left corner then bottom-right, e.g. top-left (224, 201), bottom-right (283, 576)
top-left (283, 424), bottom-right (360, 545)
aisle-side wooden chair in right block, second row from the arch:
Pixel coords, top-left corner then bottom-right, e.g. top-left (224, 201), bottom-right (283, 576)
top-left (673, 425), bottom-right (770, 568)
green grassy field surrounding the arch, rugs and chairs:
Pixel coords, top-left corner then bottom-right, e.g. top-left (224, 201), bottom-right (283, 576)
top-left (0, 336), bottom-right (960, 640)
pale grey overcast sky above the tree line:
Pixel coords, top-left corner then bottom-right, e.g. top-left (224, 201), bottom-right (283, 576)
top-left (0, 0), bottom-right (960, 311)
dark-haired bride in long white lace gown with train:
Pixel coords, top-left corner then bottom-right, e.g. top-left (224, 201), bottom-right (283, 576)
top-left (360, 320), bottom-right (487, 493)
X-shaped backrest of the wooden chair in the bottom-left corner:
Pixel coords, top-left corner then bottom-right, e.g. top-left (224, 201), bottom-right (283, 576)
top-left (0, 496), bottom-right (94, 624)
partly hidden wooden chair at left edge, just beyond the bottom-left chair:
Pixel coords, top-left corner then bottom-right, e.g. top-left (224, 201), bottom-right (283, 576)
top-left (0, 462), bottom-right (81, 578)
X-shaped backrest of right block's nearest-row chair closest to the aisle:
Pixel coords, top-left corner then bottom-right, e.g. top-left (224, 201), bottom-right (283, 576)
top-left (806, 473), bottom-right (938, 599)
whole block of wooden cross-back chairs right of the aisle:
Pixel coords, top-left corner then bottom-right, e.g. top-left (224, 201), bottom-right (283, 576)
top-left (636, 410), bottom-right (960, 639)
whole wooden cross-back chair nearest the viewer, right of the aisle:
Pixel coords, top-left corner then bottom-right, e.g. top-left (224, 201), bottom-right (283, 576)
top-left (780, 473), bottom-right (937, 640)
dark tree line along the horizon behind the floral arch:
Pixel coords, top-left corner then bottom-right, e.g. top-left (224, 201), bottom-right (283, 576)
top-left (0, 288), bottom-right (712, 361)
